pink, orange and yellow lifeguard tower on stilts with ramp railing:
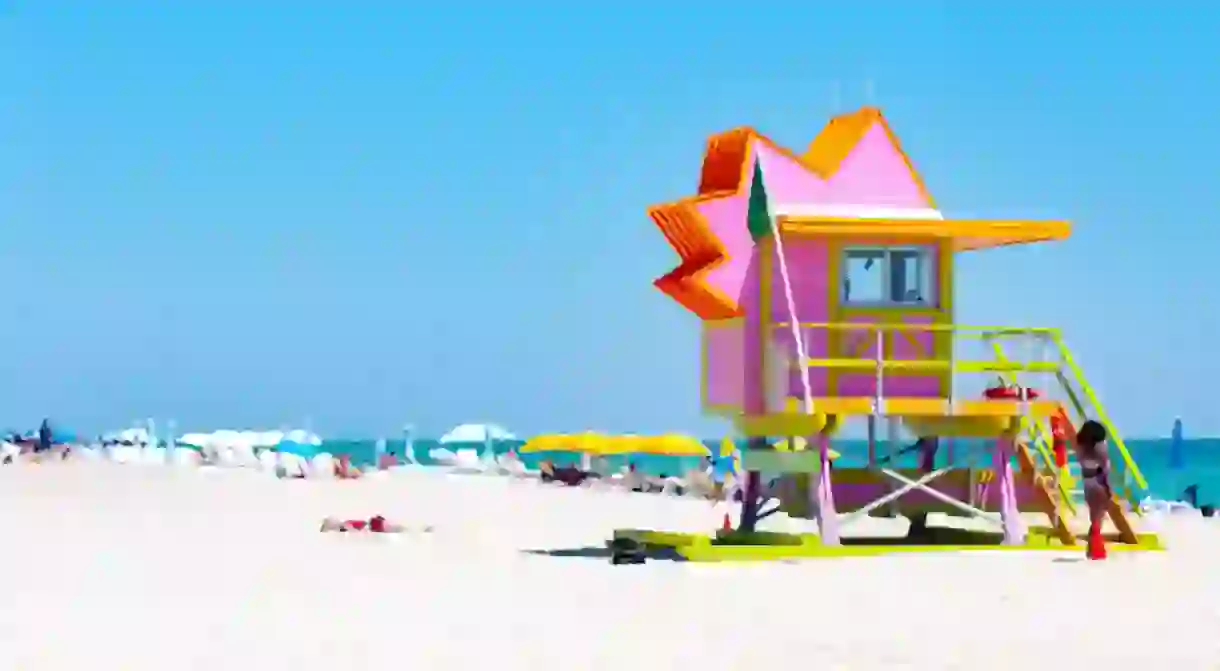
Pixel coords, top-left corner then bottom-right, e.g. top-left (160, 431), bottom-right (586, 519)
top-left (649, 107), bottom-right (1154, 558)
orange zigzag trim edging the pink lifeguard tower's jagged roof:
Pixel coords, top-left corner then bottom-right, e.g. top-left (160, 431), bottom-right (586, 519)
top-left (648, 107), bottom-right (935, 320)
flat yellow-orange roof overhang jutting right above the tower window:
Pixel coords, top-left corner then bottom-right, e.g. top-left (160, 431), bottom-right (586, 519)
top-left (778, 216), bottom-right (1071, 251)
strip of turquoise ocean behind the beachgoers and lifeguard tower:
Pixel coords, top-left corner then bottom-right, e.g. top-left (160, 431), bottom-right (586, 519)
top-left (322, 438), bottom-right (1220, 505)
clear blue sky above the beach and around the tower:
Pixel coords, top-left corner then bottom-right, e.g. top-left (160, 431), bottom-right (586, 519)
top-left (0, 0), bottom-right (1220, 436)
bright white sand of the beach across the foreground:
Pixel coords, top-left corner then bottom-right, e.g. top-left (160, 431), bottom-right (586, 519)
top-left (0, 464), bottom-right (1220, 671)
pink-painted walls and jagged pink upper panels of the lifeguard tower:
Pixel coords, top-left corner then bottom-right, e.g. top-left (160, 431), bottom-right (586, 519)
top-left (699, 124), bottom-right (941, 412)
